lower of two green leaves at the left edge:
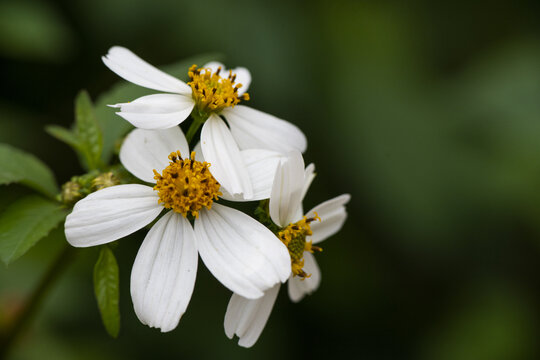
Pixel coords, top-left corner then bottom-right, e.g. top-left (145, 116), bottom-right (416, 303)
top-left (0, 195), bottom-right (67, 265)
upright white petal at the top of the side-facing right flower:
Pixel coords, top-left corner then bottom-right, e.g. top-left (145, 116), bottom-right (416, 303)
top-left (270, 151), bottom-right (304, 227)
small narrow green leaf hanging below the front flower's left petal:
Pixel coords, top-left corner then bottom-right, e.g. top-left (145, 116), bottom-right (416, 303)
top-left (94, 245), bottom-right (120, 338)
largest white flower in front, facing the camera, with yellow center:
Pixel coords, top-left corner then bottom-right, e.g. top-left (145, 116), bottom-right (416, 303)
top-left (65, 127), bottom-right (290, 332)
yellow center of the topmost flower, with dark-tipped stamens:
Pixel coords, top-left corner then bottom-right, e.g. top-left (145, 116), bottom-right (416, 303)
top-left (188, 65), bottom-right (249, 113)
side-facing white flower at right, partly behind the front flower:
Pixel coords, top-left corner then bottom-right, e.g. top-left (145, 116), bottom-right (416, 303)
top-left (224, 152), bottom-right (350, 347)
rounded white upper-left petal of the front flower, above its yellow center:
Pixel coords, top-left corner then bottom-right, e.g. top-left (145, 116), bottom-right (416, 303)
top-left (120, 126), bottom-right (189, 183)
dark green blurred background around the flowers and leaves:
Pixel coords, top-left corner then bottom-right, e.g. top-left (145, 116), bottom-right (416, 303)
top-left (0, 0), bottom-right (540, 360)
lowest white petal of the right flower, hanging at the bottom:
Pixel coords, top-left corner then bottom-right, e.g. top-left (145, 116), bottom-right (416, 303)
top-left (224, 284), bottom-right (281, 348)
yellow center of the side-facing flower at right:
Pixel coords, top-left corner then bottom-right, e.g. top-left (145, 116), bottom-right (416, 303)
top-left (278, 213), bottom-right (322, 280)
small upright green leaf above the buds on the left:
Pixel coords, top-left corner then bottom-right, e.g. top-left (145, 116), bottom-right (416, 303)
top-left (75, 90), bottom-right (103, 170)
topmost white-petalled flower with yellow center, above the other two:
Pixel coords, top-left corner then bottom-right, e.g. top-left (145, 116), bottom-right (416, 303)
top-left (103, 46), bottom-right (307, 199)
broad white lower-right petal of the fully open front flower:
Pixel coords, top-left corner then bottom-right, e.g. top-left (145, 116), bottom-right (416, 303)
top-left (195, 204), bottom-right (291, 299)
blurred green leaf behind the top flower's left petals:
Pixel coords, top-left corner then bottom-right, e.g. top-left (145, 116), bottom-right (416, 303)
top-left (95, 54), bottom-right (223, 164)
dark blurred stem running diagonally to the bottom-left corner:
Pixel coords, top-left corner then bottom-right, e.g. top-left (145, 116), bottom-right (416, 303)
top-left (0, 243), bottom-right (75, 359)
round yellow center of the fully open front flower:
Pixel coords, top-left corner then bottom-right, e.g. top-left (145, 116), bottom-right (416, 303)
top-left (154, 151), bottom-right (221, 217)
